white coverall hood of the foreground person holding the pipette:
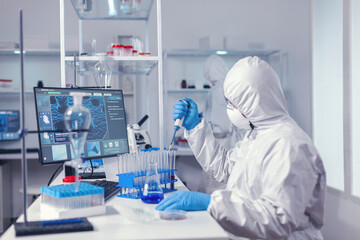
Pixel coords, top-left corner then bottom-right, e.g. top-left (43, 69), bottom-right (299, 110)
top-left (224, 57), bottom-right (289, 128)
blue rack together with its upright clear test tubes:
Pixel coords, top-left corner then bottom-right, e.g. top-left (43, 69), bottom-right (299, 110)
top-left (117, 148), bottom-right (177, 199)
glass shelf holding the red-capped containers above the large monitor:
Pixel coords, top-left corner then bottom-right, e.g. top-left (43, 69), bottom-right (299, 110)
top-left (65, 56), bottom-right (158, 75)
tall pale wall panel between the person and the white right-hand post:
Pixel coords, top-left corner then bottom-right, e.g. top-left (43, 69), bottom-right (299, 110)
top-left (313, 0), bottom-right (344, 190)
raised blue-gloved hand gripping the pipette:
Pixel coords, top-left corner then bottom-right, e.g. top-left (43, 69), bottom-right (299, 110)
top-left (173, 98), bottom-right (200, 130)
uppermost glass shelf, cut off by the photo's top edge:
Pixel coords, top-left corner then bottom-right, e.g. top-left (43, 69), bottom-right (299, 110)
top-left (71, 0), bottom-right (154, 20)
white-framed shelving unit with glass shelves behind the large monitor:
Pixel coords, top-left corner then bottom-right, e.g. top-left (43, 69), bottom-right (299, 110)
top-left (59, 0), bottom-right (164, 147)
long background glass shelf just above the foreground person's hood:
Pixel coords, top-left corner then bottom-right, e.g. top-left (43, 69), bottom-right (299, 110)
top-left (164, 49), bottom-right (281, 57)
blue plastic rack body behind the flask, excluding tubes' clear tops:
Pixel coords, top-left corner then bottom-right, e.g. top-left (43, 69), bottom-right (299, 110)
top-left (117, 169), bottom-right (177, 199)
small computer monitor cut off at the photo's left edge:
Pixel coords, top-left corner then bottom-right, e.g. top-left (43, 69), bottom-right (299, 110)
top-left (0, 110), bottom-right (20, 141)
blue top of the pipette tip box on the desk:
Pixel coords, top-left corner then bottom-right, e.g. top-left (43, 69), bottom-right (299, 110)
top-left (41, 183), bottom-right (104, 198)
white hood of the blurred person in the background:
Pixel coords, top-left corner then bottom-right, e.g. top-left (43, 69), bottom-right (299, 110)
top-left (204, 55), bottom-right (228, 86)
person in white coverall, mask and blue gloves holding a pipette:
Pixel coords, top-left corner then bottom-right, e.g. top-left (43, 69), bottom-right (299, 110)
top-left (156, 57), bottom-right (326, 240)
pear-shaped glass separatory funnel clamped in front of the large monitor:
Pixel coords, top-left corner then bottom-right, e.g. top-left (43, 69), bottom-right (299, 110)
top-left (64, 92), bottom-right (91, 191)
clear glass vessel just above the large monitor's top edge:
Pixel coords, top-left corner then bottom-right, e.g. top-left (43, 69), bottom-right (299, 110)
top-left (94, 53), bottom-right (112, 89)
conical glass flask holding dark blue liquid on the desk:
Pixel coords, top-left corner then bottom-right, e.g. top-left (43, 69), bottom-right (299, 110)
top-left (141, 161), bottom-right (164, 204)
